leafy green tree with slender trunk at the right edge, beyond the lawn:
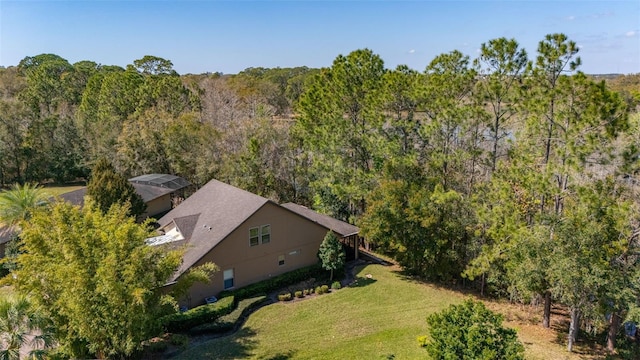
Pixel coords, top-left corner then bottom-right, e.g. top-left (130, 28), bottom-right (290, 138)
top-left (548, 179), bottom-right (640, 351)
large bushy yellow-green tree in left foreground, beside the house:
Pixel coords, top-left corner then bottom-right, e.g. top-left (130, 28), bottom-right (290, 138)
top-left (13, 201), bottom-right (213, 359)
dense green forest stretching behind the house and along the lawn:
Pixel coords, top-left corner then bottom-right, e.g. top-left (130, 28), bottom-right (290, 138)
top-left (0, 34), bottom-right (640, 350)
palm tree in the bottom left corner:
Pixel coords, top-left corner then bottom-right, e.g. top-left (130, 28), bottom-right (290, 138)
top-left (0, 296), bottom-right (53, 360)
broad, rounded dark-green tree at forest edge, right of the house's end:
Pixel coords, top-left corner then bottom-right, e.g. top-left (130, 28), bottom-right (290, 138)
top-left (359, 164), bottom-right (468, 280)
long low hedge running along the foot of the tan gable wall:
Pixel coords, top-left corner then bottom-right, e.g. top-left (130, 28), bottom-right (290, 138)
top-left (220, 264), bottom-right (326, 301)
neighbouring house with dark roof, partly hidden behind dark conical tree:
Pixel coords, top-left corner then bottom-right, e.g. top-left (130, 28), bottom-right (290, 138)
top-left (60, 174), bottom-right (191, 218)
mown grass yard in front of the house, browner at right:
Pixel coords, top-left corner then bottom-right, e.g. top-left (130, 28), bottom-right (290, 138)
top-left (173, 265), bottom-right (590, 360)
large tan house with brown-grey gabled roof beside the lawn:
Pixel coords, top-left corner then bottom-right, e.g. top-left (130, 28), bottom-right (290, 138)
top-left (152, 180), bottom-right (358, 307)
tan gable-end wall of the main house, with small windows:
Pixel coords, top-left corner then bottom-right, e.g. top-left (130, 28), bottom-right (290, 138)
top-left (183, 203), bottom-right (327, 307)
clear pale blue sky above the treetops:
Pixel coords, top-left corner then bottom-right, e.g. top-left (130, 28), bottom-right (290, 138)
top-left (0, 0), bottom-right (640, 74)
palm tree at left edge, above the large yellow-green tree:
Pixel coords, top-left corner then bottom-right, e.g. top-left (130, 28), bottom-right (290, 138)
top-left (0, 184), bottom-right (49, 226)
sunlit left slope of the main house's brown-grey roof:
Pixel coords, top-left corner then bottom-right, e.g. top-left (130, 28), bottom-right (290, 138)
top-left (158, 180), bottom-right (269, 280)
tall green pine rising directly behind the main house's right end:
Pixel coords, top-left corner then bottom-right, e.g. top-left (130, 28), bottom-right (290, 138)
top-left (294, 49), bottom-right (385, 219)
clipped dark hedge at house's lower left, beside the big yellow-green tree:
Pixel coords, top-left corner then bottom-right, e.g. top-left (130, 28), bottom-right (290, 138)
top-left (160, 296), bottom-right (236, 333)
